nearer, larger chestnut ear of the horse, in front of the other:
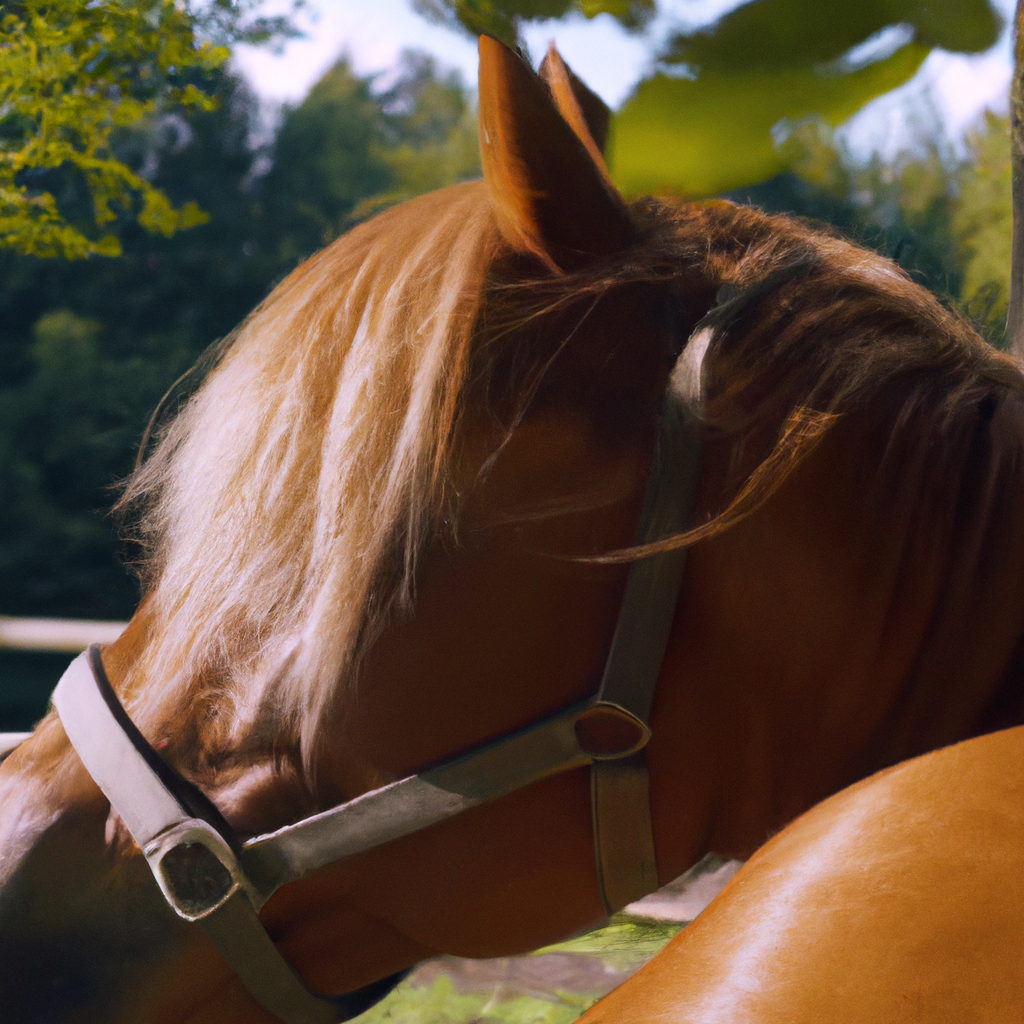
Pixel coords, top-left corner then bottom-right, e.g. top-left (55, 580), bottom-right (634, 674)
top-left (480, 36), bottom-right (635, 271)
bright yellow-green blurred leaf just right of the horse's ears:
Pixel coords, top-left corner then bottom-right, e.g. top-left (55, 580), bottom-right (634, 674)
top-left (609, 43), bottom-right (929, 198)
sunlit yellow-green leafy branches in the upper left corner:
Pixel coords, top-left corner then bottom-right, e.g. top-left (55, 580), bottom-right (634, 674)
top-left (0, 0), bottom-right (294, 259)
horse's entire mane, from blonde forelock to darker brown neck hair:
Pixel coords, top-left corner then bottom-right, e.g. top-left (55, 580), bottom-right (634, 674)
top-left (114, 182), bottom-right (1021, 771)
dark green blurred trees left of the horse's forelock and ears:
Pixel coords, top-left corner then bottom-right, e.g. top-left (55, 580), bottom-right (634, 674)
top-left (0, 55), bottom-right (479, 618)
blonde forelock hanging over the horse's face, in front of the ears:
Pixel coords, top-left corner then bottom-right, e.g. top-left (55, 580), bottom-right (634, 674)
top-left (122, 182), bottom-right (497, 766)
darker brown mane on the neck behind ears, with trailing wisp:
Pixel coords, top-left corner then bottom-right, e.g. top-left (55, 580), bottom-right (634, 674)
top-left (622, 201), bottom-right (1024, 560)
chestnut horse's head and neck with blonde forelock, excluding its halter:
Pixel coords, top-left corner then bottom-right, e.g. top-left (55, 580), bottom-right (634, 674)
top-left (0, 38), bottom-right (1024, 1024)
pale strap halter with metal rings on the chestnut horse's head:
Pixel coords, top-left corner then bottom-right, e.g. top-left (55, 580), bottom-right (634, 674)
top-left (53, 385), bottom-right (699, 1024)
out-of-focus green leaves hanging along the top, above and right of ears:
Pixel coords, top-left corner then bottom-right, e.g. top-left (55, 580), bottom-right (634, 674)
top-left (413, 0), bottom-right (1002, 197)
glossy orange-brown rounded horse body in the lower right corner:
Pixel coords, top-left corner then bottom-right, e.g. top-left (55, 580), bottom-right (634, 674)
top-left (582, 728), bottom-right (1024, 1024)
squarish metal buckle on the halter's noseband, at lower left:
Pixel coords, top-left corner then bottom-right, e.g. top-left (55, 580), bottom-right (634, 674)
top-left (142, 818), bottom-right (262, 921)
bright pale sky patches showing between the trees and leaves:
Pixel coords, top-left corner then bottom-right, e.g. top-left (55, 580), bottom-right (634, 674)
top-left (236, 0), bottom-right (1014, 155)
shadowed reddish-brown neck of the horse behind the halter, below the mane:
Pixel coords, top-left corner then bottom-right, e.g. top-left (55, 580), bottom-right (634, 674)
top-left (649, 376), bottom-right (1024, 876)
